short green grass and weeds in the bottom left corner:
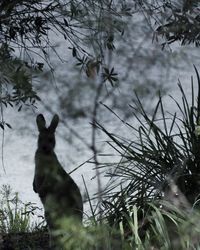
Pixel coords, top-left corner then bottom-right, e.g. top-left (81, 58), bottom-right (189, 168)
top-left (0, 185), bottom-right (49, 250)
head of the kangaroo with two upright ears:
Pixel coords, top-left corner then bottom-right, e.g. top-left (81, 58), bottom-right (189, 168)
top-left (36, 114), bottom-right (59, 154)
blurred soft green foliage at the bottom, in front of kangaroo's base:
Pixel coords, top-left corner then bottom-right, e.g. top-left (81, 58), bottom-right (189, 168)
top-left (54, 218), bottom-right (121, 250)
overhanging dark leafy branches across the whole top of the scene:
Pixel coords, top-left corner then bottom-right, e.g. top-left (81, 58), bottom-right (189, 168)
top-left (0, 0), bottom-right (199, 122)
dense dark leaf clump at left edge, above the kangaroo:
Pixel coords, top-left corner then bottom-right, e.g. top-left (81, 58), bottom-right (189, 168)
top-left (0, 44), bottom-right (42, 117)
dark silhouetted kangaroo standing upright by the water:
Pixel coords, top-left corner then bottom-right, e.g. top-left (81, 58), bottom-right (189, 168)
top-left (33, 114), bottom-right (83, 247)
